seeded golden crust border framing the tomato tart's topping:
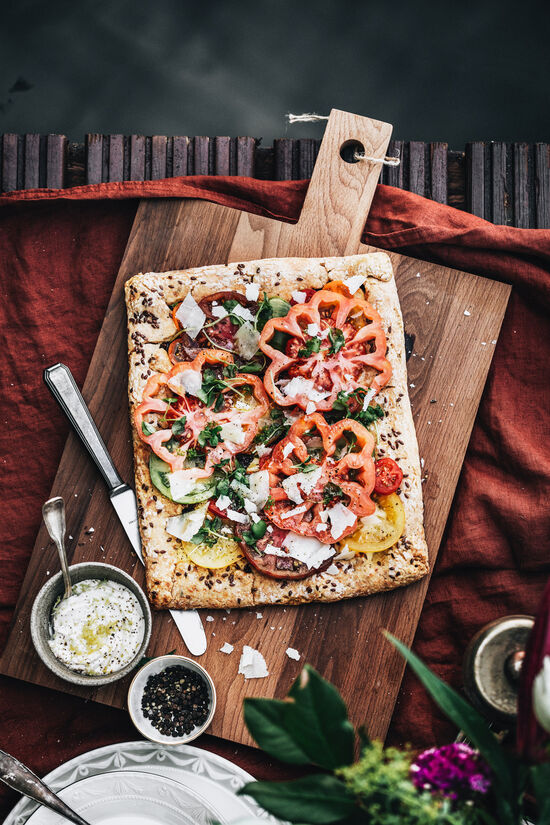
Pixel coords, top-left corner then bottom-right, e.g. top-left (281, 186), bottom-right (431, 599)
top-left (125, 252), bottom-right (429, 609)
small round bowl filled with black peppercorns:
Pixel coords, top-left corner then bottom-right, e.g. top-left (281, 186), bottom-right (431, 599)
top-left (128, 654), bottom-right (216, 745)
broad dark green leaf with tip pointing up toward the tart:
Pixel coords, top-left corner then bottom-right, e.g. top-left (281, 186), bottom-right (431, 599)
top-left (284, 665), bottom-right (355, 770)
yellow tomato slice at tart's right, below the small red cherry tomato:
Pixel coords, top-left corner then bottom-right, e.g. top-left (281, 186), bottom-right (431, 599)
top-left (342, 493), bottom-right (405, 553)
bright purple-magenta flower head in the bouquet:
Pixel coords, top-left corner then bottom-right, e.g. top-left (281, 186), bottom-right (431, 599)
top-left (411, 743), bottom-right (491, 800)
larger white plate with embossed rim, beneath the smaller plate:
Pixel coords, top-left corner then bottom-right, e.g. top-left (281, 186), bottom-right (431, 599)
top-left (3, 742), bottom-right (280, 825)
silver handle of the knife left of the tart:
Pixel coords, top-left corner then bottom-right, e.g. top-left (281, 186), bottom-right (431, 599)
top-left (44, 364), bottom-right (123, 491)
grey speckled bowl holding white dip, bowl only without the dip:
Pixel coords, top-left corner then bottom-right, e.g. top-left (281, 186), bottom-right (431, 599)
top-left (31, 562), bottom-right (151, 687)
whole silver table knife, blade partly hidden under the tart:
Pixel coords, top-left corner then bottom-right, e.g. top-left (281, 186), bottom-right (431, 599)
top-left (44, 364), bottom-right (206, 656)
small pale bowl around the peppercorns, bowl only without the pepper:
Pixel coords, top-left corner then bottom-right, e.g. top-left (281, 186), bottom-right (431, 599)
top-left (128, 653), bottom-right (216, 745)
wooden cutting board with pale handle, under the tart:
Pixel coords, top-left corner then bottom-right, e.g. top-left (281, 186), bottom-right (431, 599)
top-left (0, 111), bottom-right (510, 744)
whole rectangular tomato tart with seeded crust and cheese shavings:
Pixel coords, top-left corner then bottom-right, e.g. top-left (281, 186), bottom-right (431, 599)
top-left (126, 252), bottom-right (428, 608)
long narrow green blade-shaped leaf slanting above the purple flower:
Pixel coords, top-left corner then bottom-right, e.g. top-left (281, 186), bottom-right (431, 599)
top-left (384, 631), bottom-right (520, 825)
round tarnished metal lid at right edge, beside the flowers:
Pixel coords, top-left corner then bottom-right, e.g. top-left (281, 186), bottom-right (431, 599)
top-left (463, 615), bottom-right (534, 725)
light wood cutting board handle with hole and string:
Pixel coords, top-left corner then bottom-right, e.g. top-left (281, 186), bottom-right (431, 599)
top-left (292, 109), bottom-right (392, 255)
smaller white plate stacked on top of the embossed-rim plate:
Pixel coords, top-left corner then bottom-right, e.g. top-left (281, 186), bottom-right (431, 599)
top-left (28, 771), bottom-right (218, 825)
